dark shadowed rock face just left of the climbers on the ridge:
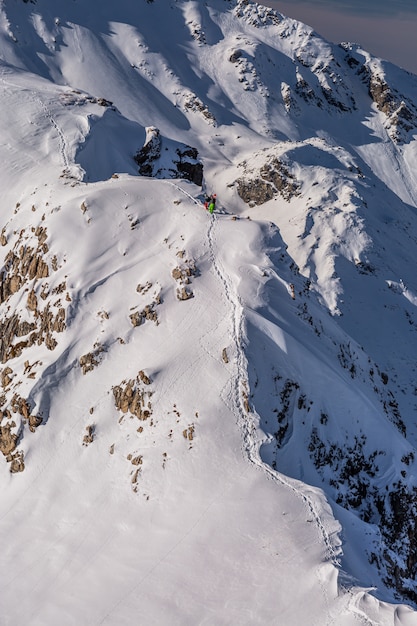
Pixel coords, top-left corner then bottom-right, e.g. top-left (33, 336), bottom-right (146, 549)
top-left (134, 126), bottom-right (203, 187)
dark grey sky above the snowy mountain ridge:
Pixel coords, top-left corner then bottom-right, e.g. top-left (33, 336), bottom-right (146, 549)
top-left (262, 0), bottom-right (417, 74)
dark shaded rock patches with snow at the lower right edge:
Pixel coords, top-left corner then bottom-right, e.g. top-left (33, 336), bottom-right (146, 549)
top-left (308, 421), bottom-right (417, 603)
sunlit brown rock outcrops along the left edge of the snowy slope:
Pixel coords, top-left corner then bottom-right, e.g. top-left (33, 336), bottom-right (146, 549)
top-left (0, 226), bottom-right (70, 473)
